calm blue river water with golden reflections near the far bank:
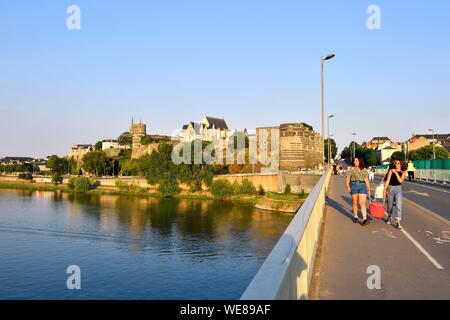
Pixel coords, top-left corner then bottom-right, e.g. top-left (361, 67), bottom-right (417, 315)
top-left (0, 190), bottom-right (292, 300)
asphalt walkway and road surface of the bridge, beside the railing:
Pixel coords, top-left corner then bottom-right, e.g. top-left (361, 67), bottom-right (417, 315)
top-left (310, 176), bottom-right (450, 300)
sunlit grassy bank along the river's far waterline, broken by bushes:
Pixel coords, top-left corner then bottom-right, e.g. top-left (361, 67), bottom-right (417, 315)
top-left (0, 181), bottom-right (307, 213)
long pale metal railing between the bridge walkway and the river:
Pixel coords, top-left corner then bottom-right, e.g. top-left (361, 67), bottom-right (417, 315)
top-left (241, 171), bottom-right (331, 300)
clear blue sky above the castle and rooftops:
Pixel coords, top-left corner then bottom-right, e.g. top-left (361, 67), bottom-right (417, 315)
top-left (0, 0), bottom-right (450, 157)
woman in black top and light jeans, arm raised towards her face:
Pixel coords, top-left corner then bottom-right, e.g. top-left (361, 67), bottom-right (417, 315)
top-left (384, 160), bottom-right (408, 229)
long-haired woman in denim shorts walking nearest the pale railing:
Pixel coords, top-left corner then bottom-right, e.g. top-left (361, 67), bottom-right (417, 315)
top-left (345, 158), bottom-right (370, 226)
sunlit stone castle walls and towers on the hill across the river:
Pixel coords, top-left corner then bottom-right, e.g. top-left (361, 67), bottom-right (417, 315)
top-left (69, 116), bottom-right (323, 172)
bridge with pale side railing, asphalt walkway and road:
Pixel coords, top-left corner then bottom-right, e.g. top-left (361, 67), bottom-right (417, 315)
top-left (241, 172), bottom-right (450, 300)
